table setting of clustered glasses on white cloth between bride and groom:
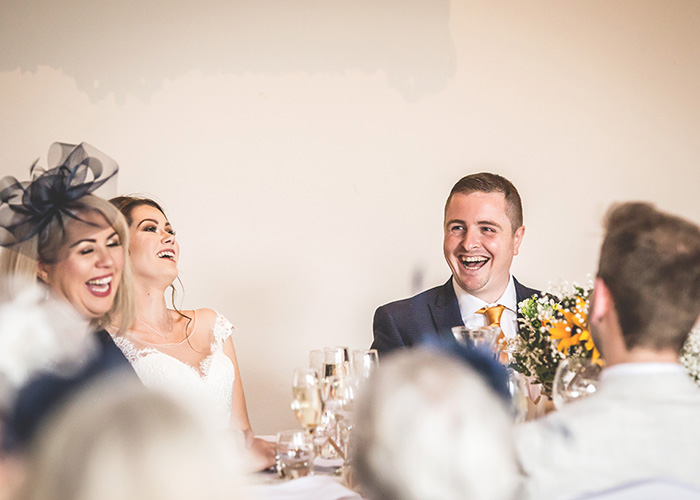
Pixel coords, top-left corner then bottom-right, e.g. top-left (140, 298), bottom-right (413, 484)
top-left (249, 346), bottom-right (379, 500)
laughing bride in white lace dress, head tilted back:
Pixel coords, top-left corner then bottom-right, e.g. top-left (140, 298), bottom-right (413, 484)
top-left (112, 196), bottom-right (274, 468)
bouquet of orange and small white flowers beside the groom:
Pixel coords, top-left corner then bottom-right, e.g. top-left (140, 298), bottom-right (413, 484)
top-left (508, 284), bottom-right (600, 399)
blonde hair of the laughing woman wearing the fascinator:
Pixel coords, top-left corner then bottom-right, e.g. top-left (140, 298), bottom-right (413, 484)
top-left (0, 195), bottom-right (135, 335)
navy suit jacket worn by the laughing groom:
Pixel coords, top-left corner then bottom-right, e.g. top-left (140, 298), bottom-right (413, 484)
top-left (372, 278), bottom-right (540, 356)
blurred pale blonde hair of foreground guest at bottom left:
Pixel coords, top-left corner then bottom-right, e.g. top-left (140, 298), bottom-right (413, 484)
top-left (19, 378), bottom-right (243, 500)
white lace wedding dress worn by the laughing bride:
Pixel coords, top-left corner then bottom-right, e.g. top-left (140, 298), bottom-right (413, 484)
top-left (114, 313), bottom-right (236, 429)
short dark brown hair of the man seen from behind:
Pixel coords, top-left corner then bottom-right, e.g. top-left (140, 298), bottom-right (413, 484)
top-left (598, 203), bottom-right (700, 351)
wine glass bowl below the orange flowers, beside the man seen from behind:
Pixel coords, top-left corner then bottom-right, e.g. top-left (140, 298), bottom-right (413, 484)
top-left (552, 358), bottom-right (602, 410)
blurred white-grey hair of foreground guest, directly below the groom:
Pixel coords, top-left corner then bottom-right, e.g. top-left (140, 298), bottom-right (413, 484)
top-left (352, 349), bottom-right (518, 500)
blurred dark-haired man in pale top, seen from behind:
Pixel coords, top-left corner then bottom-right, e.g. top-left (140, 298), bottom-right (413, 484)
top-left (516, 203), bottom-right (700, 500)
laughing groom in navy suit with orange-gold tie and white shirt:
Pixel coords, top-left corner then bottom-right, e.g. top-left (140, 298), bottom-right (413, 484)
top-left (372, 172), bottom-right (538, 355)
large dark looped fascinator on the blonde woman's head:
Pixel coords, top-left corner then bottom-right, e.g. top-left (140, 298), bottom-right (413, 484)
top-left (0, 142), bottom-right (119, 251)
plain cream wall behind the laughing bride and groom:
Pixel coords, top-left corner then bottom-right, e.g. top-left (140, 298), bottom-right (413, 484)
top-left (0, 0), bottom-right (700, 433)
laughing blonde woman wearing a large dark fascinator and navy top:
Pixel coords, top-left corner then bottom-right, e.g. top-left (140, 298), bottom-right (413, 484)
top-left (0, 143), bottom-right (134, 449)
